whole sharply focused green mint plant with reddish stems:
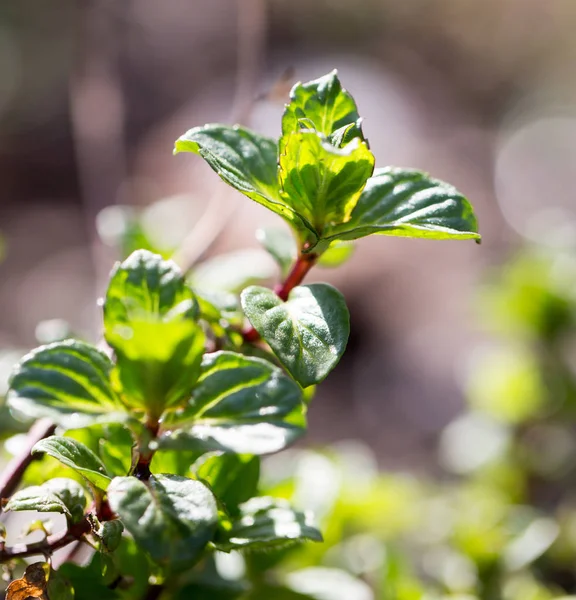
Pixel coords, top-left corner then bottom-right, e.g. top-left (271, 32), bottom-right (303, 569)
top-left (0, 72), bottom-right (480, 600)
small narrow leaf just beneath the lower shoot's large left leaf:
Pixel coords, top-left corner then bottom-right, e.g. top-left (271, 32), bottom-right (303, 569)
top-left (32, 435), bottom-right (110, 490)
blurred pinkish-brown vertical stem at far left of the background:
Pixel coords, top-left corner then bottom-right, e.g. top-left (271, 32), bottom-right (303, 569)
top-left (69, 1), bottom-right (127, 293)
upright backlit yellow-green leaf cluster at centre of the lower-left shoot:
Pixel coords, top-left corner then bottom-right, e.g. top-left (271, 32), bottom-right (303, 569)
top-left (104, 250), bottom-right (205, 416)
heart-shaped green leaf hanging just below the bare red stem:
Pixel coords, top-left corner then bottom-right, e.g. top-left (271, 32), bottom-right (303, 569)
top-left (241, 283), bottom-right (350, 387)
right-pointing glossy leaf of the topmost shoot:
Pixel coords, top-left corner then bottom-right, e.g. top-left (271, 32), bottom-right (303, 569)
top-left (325, 167), bottom-right (480, 240)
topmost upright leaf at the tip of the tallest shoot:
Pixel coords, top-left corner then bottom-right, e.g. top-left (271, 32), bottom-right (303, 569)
top-left (282, 70), bottom-right (361, 142)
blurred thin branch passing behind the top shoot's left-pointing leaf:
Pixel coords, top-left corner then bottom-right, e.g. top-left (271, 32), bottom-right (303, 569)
top-left (174, 0), bottom-right (268, 272)
